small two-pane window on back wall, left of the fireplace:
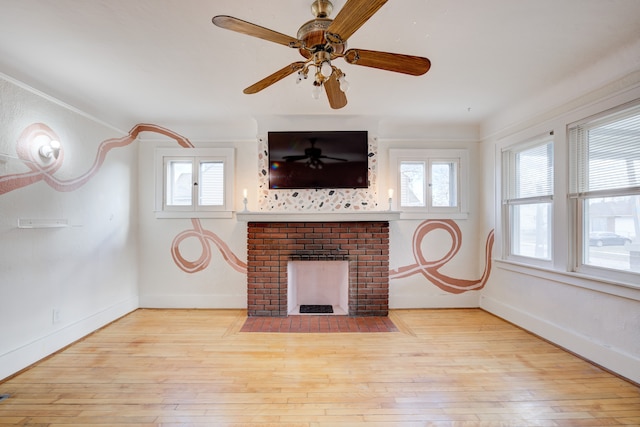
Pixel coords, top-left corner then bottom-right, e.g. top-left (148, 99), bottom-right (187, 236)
top-left (156, 148), bottom-right (234, 218)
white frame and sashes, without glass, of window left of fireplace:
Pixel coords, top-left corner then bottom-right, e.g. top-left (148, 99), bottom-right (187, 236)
top-left (155, 148), bottom-right (235, 218)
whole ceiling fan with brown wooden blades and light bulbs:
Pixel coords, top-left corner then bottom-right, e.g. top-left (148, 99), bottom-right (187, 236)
top-left (212, 0), bottom-right (431, 109)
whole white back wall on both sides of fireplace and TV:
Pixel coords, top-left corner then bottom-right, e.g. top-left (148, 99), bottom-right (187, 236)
top-left (134, 117), bottom-right (486, 308)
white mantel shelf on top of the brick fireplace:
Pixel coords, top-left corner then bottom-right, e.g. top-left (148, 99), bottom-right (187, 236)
top-left (236, 211), bottom-right (400, 222)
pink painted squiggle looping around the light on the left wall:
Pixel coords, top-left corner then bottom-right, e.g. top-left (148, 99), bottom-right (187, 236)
top-left (0, 123), bottom-right (193, 195)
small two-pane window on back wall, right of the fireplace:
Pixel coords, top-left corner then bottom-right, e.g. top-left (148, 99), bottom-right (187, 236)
top-left (389, 149), bottom-right (467, 214)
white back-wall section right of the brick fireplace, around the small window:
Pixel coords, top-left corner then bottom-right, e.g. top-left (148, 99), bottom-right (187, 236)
top-left (378, 137), bottom-right (488, 309)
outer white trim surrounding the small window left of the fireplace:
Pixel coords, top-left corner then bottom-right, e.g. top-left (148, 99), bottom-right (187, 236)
top-left (154, 148), bottom-right (235, 218)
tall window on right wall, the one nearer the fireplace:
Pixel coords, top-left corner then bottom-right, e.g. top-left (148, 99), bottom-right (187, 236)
top-left (502, 136), bottom-right (553, 261)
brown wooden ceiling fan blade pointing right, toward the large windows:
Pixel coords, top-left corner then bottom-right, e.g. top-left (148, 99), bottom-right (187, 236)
top-left (344, 49), bottom-right (431, 76)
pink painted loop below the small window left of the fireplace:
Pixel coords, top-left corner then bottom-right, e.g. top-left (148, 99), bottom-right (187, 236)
top-left (171, 218), bottom-right (247, 273)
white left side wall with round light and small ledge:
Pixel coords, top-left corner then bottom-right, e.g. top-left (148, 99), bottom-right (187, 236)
top-left (0, 75), bottom-right (138, 379)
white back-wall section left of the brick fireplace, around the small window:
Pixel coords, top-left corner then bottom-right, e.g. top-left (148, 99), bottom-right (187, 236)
top-left (138, 138), bottom-right (252, 308)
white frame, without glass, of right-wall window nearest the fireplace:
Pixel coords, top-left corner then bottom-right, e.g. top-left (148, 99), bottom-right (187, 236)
top-left (500, 132), bottom-right (556, 268)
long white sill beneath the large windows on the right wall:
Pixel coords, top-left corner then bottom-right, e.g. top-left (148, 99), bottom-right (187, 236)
top-left (494, 259), bottom-right (640, 301)
